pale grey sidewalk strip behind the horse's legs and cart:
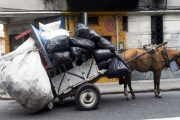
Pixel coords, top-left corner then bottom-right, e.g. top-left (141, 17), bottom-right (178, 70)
top-left (0, 79), bottom-right (180, 100)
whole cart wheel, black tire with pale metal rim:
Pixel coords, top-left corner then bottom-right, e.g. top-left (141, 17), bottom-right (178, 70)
top-left (75, 83), bottom-right (101, 110)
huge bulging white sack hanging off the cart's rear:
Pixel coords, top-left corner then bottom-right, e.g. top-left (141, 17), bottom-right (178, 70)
top-left (0, 38), bottom-right (53, 113)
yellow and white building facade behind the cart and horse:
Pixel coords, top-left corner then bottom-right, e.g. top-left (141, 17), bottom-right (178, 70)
top-left (0, 0), bottom-right (180, 81)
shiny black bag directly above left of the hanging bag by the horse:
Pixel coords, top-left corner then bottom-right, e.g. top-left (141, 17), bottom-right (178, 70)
top-left (94, 49), bottom-right (114, 62)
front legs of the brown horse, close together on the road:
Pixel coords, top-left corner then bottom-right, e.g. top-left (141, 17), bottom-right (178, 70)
top-left (154, 70), bottom-right (161, 98)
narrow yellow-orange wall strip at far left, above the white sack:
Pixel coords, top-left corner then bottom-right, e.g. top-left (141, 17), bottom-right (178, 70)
top-left (4, 24), bottom-right (10, 54)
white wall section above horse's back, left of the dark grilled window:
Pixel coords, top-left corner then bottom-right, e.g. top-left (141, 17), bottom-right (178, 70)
top-left (126, 15), bottom-right (151, 48)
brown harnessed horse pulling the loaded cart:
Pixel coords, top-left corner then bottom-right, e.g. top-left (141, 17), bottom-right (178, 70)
top-left (121, 48), bottom-right (180, 100)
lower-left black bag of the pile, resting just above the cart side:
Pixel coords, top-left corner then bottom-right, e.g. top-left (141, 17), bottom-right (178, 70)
top-left (52, 51), bottom-right (72, 68)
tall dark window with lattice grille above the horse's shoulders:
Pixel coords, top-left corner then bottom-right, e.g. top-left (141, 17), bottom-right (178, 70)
top-left (151, 16), bottom-right (163, 45)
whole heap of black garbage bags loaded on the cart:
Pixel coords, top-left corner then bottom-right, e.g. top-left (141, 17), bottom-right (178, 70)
top-left (44, 23), bottom-right (131, 78)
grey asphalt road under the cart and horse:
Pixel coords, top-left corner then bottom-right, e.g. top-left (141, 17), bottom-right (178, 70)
top-left (0, 91), bottom-right (180, 120)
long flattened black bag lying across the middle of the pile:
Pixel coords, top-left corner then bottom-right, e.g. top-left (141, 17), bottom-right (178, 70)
top-left (70, 37), bottom-right (95, 52)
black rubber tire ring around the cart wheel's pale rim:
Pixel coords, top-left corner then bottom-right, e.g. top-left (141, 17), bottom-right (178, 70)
top-left (75, 83), bottom-right (101, 111)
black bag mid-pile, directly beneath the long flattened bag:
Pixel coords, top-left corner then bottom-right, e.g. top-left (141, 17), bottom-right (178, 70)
top-left (70, 47), bottom-right (90, 58)
